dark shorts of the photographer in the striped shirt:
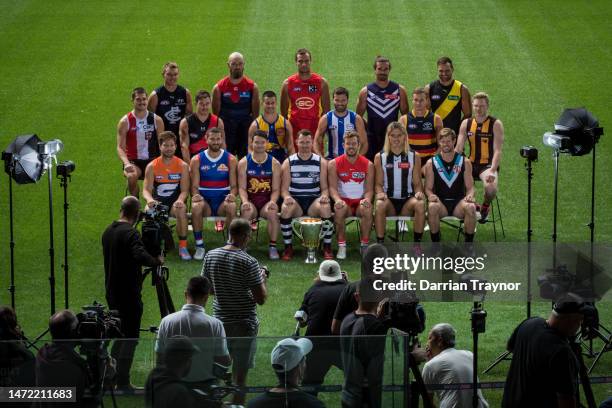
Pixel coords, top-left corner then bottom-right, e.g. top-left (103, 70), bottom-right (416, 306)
top-left (223, 322), bottom-right (259, 372)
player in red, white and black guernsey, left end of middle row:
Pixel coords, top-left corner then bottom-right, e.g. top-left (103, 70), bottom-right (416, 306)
top-left (117, 88), bottom-right (164, 197)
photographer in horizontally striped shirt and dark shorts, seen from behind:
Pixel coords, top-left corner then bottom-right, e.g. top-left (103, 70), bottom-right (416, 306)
top-left (202, 218), bottom-right (268, 404)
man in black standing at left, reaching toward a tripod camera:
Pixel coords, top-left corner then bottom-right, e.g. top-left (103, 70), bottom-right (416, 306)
top-left (102, 196), bottom-right (164, 392)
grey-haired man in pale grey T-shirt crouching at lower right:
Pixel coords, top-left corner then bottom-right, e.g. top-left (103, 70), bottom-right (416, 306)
top-left (423, 323), bottom-right (489, 408)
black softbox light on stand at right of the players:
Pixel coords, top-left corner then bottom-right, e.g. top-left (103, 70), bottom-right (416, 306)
top-left (555, 108), bottom-right (603, 156)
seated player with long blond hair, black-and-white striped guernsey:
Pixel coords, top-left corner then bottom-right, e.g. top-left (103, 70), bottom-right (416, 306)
top-left (374, 122), bottom-right (425, 243)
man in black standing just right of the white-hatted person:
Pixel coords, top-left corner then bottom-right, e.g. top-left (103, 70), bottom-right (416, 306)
top-left (340, 278), bottom-right (389, 408)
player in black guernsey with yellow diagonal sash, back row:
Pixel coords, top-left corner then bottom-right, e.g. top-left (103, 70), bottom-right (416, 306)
top-left (425, 57), bottom-right (472, 134)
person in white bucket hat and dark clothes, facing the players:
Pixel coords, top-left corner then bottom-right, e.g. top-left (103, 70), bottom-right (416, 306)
top-left (300, 260), bottom-right (347, 396)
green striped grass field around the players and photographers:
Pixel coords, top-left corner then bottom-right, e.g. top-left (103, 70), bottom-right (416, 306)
top-left (0, 0), bottom-right (612, 406)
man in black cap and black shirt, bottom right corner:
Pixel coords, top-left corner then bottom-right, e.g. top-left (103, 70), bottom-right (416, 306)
top-left (502, 301), bottom-right (588, 408)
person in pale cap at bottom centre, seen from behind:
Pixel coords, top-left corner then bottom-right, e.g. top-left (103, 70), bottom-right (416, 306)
top-left (247, 338), bottom-right (325, 408)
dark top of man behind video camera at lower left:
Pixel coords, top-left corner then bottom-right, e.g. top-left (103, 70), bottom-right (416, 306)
top-left (36, 342), bottom-right (91, 408)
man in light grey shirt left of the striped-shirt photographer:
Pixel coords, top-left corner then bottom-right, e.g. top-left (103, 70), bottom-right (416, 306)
top-left (155, 276), bottom-right (231, 383)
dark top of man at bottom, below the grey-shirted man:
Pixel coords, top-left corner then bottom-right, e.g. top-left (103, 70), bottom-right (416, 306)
top-left (145, 365), bottom-right (197, 408)
